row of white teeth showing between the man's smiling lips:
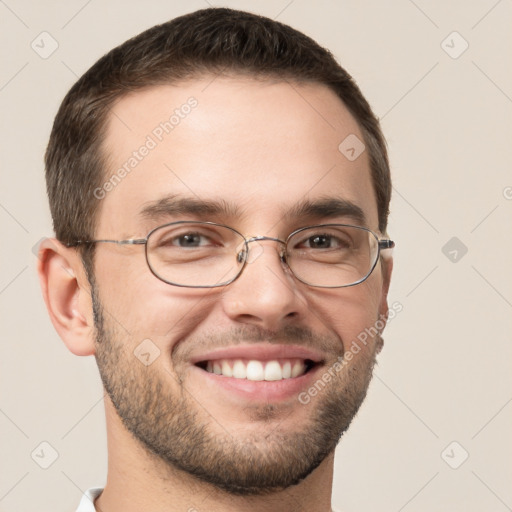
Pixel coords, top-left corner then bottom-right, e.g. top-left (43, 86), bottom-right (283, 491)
top-left (196, 358), bottom-right (320, 381)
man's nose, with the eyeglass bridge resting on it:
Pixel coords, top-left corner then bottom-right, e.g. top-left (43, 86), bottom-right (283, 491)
top-left (222, 237), bottom-right (305, 330)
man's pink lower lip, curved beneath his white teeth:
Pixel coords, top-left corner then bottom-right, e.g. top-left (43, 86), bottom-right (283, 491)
top-left (190, 364), bottom-right (322, 402)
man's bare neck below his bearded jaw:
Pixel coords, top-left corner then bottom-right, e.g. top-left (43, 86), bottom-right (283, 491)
top-left (95, 398), bottom-right (334, 512)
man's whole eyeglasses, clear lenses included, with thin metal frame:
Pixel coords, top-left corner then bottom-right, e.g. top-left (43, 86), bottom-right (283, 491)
top-left (69, 220), bottom-right (395, 288)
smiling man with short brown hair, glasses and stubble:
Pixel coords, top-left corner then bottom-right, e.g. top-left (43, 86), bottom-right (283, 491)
top-left (39, 9), bottom-right (394, 512)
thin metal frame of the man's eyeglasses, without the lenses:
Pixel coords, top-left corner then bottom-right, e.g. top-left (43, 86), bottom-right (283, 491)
top-left (67, 220), bottom-right (395, 288)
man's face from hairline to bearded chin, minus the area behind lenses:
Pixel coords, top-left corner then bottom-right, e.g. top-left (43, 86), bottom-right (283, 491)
top-left (93, 76), bottom-right (388, 494)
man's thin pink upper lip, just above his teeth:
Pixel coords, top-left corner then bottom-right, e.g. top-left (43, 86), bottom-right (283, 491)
top-left (191, 343), bottom-right (325, 364)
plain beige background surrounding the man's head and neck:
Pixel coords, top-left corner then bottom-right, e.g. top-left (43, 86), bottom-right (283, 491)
top-left (0, 0), bottom-right (512, 512)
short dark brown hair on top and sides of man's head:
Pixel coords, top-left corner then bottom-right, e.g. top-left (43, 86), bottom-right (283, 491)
top-left (45, 8), bottom-right (391, 251)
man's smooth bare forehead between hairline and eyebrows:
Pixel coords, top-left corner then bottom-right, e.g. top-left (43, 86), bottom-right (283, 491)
top-left (96, 76), bottom-right (378, 236)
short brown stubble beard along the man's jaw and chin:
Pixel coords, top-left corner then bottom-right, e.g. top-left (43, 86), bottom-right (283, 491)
top-left (92, 286), bottom-right (375, 496)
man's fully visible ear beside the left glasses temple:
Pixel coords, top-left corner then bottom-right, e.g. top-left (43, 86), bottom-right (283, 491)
top-left (37, 238), bottom-right (95, 356)
